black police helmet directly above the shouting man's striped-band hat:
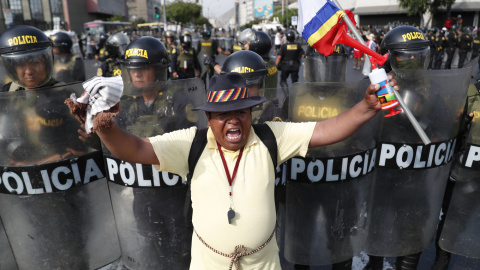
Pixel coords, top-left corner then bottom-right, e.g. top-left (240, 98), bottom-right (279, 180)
top-left (221, 51), bottom-right (268, 88)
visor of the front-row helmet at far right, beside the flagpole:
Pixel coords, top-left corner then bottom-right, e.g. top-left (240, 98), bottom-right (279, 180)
top-left (390, 47), bottom-right (430, 71)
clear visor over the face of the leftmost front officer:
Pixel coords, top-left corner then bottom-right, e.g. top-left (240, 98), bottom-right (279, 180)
top-left (1, 47), bottom-right (53, 88)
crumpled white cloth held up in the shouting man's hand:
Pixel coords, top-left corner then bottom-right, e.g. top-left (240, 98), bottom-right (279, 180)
top-left (74, 76), bottom-right (123, 134)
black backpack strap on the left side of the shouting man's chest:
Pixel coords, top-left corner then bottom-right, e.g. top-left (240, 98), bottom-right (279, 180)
top-left (183, 128), bottom-right (208, 227)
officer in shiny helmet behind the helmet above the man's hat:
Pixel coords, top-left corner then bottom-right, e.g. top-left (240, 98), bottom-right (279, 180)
top-left (238, 28), bottom-right (278, 89)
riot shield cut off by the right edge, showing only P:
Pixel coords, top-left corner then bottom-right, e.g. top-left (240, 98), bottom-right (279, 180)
top-left (438, 86), bottom-right (480, 258)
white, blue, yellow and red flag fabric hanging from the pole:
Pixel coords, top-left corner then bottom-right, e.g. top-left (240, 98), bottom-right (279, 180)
top-left (297, 0), bottom-right (354, 56)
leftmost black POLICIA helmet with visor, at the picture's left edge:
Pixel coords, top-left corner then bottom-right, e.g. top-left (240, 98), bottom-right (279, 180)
top-left (0, 25), bottom-right (53, 88)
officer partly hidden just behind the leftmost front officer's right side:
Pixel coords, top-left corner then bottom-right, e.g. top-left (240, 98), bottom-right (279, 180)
top-left (50, 32), bottom-right (85, 83)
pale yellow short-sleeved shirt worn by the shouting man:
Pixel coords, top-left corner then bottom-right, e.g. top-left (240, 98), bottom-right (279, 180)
top-left (149, 122), bottom-right (315, 270)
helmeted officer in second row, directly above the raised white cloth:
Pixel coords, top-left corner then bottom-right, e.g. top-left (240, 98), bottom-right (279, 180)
top-left (97, 32), bottom-right (130, 77)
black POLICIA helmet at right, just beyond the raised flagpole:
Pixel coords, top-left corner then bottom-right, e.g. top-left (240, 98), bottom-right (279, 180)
top-left (380, 26), bottom-right (430, 70)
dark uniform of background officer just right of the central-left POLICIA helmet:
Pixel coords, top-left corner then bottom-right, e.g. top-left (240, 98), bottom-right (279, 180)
top-left (170, 47), bottom-right (200, 79)
